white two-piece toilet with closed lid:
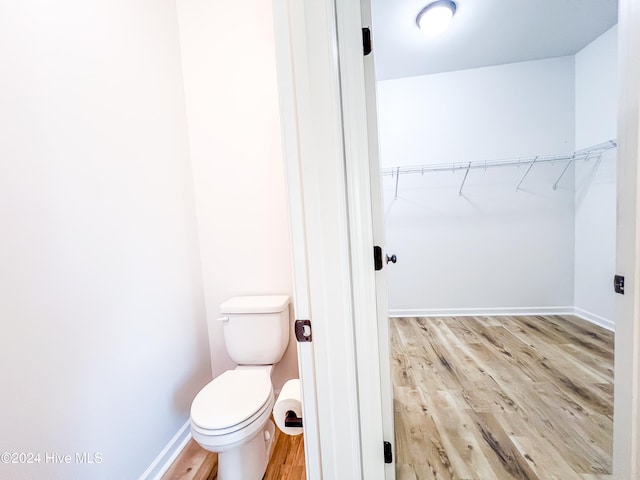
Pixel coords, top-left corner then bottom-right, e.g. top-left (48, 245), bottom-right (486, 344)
top-left (191, 295), bottom-right (289, 480)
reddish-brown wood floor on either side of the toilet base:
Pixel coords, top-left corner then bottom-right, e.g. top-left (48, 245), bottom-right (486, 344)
top-left (162, 420), bottom-right (306, 480)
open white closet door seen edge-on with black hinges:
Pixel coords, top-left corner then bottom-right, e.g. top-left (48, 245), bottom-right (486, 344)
top-left (335, 0), bottom-right (395, 480)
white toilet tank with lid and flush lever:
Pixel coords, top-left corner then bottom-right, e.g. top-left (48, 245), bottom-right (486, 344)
top-left (220, 295), bottom-right (289, 365)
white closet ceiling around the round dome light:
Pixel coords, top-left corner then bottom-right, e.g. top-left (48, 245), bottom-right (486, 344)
top-left (371, 0), bottom-right (618, 80)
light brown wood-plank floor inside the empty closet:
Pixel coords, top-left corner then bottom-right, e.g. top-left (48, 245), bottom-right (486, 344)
top-left (391, 316), bottom-right (613, 480)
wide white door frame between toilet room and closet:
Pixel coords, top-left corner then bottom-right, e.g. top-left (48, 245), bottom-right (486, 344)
top-left (274, 0), bottom-right (392, 480)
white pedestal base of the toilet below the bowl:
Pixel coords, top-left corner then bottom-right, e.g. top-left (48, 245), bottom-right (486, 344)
top-left (218, 420), bottom-right (275, 480)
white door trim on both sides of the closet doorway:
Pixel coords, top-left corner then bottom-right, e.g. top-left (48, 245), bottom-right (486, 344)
top-left (274, 0), bottom-right (640, 480)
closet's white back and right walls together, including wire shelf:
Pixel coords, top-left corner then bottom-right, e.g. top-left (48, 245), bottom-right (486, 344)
top-left (377, 31), bottom-right (617, 329)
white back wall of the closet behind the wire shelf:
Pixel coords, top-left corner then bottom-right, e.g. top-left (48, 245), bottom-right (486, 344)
top-left (378, 57), bottom-right (574, 314)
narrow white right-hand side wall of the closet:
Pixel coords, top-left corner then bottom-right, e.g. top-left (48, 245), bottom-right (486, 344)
top-left (575, 27), bottom-right (618, 326)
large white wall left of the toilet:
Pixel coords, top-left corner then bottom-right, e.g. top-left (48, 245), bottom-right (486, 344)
top-left (0, 0), bottom-right (210, 480)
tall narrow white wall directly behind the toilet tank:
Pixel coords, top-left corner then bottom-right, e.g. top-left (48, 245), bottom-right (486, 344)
top-left (178, 0), bottom-right (297, 390)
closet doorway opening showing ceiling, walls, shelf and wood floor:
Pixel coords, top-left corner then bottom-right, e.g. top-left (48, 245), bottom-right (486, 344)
top-left (372, 0), bottom-right (617, 478)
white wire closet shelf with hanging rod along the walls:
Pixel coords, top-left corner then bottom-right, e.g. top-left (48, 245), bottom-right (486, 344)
top-left (380, 140), bottom-right (617, 178)
